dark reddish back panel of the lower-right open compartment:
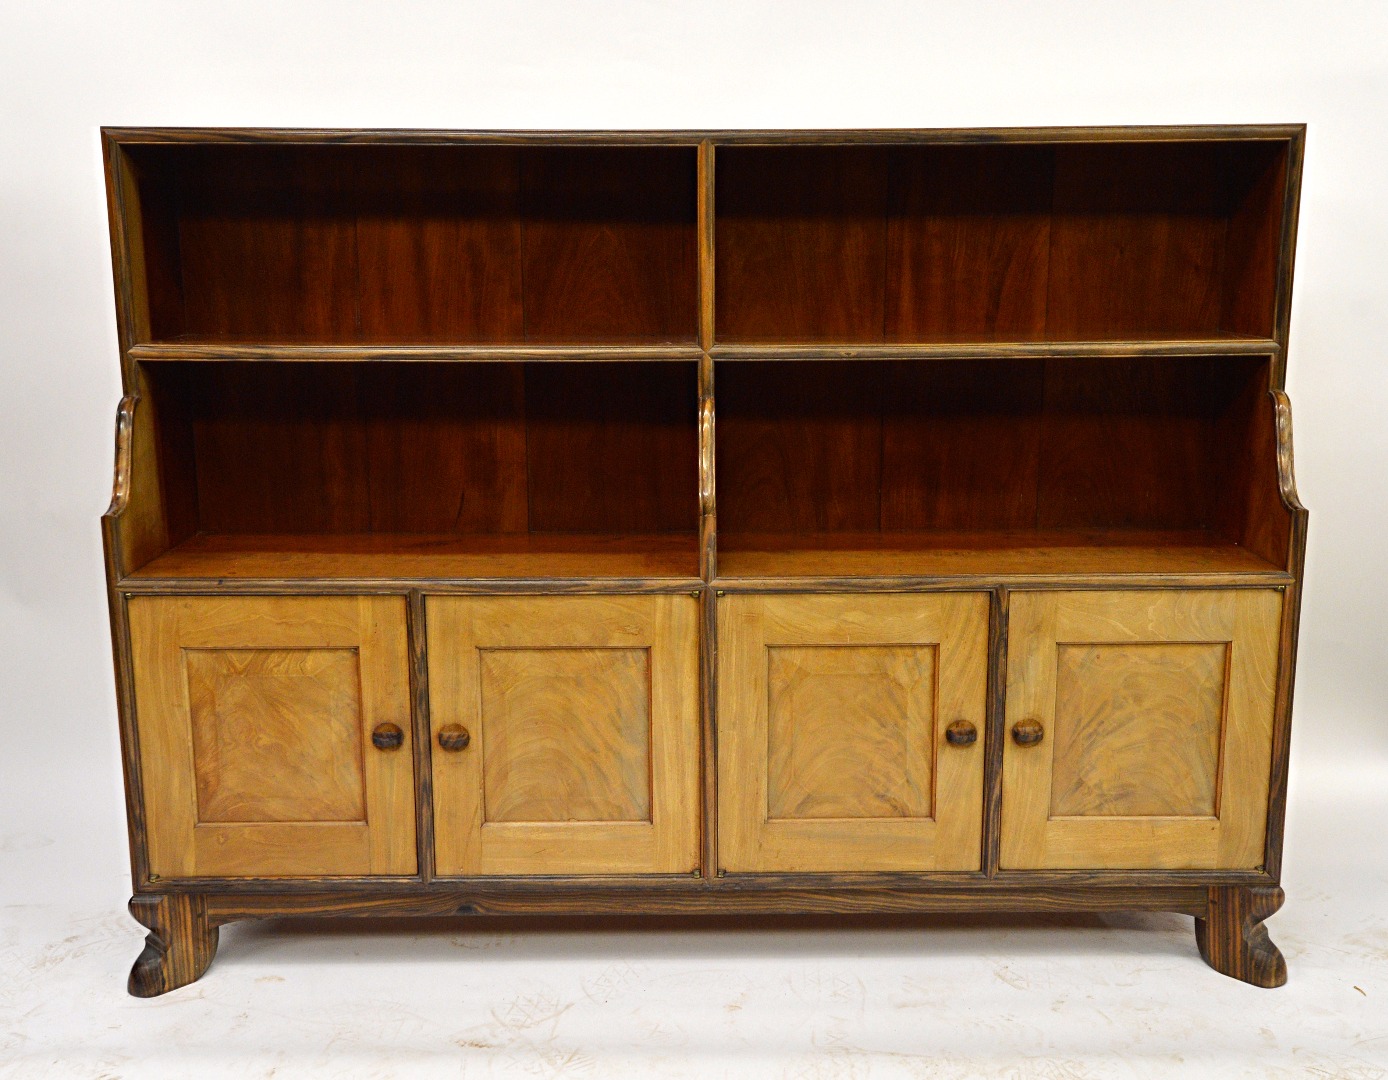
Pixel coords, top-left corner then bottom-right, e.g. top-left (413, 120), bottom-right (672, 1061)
top-left (718, 357), bottom-right (1267, 533)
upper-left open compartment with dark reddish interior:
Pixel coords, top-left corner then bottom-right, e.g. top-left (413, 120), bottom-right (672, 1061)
top-left (125, 143), bottom-right (698, 346)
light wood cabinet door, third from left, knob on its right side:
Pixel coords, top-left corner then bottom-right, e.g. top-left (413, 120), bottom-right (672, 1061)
top-left (718, 593), bottom-right (988, 872)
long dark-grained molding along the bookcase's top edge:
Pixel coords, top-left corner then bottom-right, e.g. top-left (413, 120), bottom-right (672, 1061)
top-left (101, 124), bottom-right (1306, 147)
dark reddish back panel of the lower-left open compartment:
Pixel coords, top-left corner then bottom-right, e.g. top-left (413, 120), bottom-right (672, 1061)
top-left (146, 362), bottom-right (698, 534)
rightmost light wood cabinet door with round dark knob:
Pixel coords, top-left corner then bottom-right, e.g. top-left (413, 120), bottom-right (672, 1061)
top-left (1001, 590), bottom-right (1283, 869)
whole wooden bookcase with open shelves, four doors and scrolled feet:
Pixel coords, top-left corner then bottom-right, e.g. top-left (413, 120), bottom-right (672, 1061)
top-left (103, 126), bottom-right (1306, 995)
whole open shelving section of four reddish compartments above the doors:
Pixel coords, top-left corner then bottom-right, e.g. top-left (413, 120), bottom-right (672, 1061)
top-left (114, 132), bottom-right (1295, 580)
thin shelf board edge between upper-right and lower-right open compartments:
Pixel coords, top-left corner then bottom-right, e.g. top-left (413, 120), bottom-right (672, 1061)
top-left (711, 335), bottom-right (1281, 361)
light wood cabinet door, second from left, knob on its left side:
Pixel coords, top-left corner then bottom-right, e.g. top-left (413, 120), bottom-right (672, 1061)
top-left (426, 596), bottom-right (700, 875)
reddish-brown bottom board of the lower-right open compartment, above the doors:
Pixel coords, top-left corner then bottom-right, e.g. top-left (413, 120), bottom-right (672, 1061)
top-left (718, 529), bottom-right (1285, 579)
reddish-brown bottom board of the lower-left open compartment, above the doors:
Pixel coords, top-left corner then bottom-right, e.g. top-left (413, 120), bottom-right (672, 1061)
top-left (129, 533), bottom-right (698, 580)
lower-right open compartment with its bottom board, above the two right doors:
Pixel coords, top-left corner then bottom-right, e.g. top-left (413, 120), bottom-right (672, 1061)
top-left (716, 357), bottom-right (1285, 577)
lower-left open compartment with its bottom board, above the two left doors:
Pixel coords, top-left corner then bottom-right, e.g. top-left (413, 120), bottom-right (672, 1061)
top-left (132, 361), bottom-right (698, 577)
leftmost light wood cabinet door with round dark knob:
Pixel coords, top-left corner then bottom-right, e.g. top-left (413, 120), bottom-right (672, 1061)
top-left (129, 597), bottom-right (418, 877)
